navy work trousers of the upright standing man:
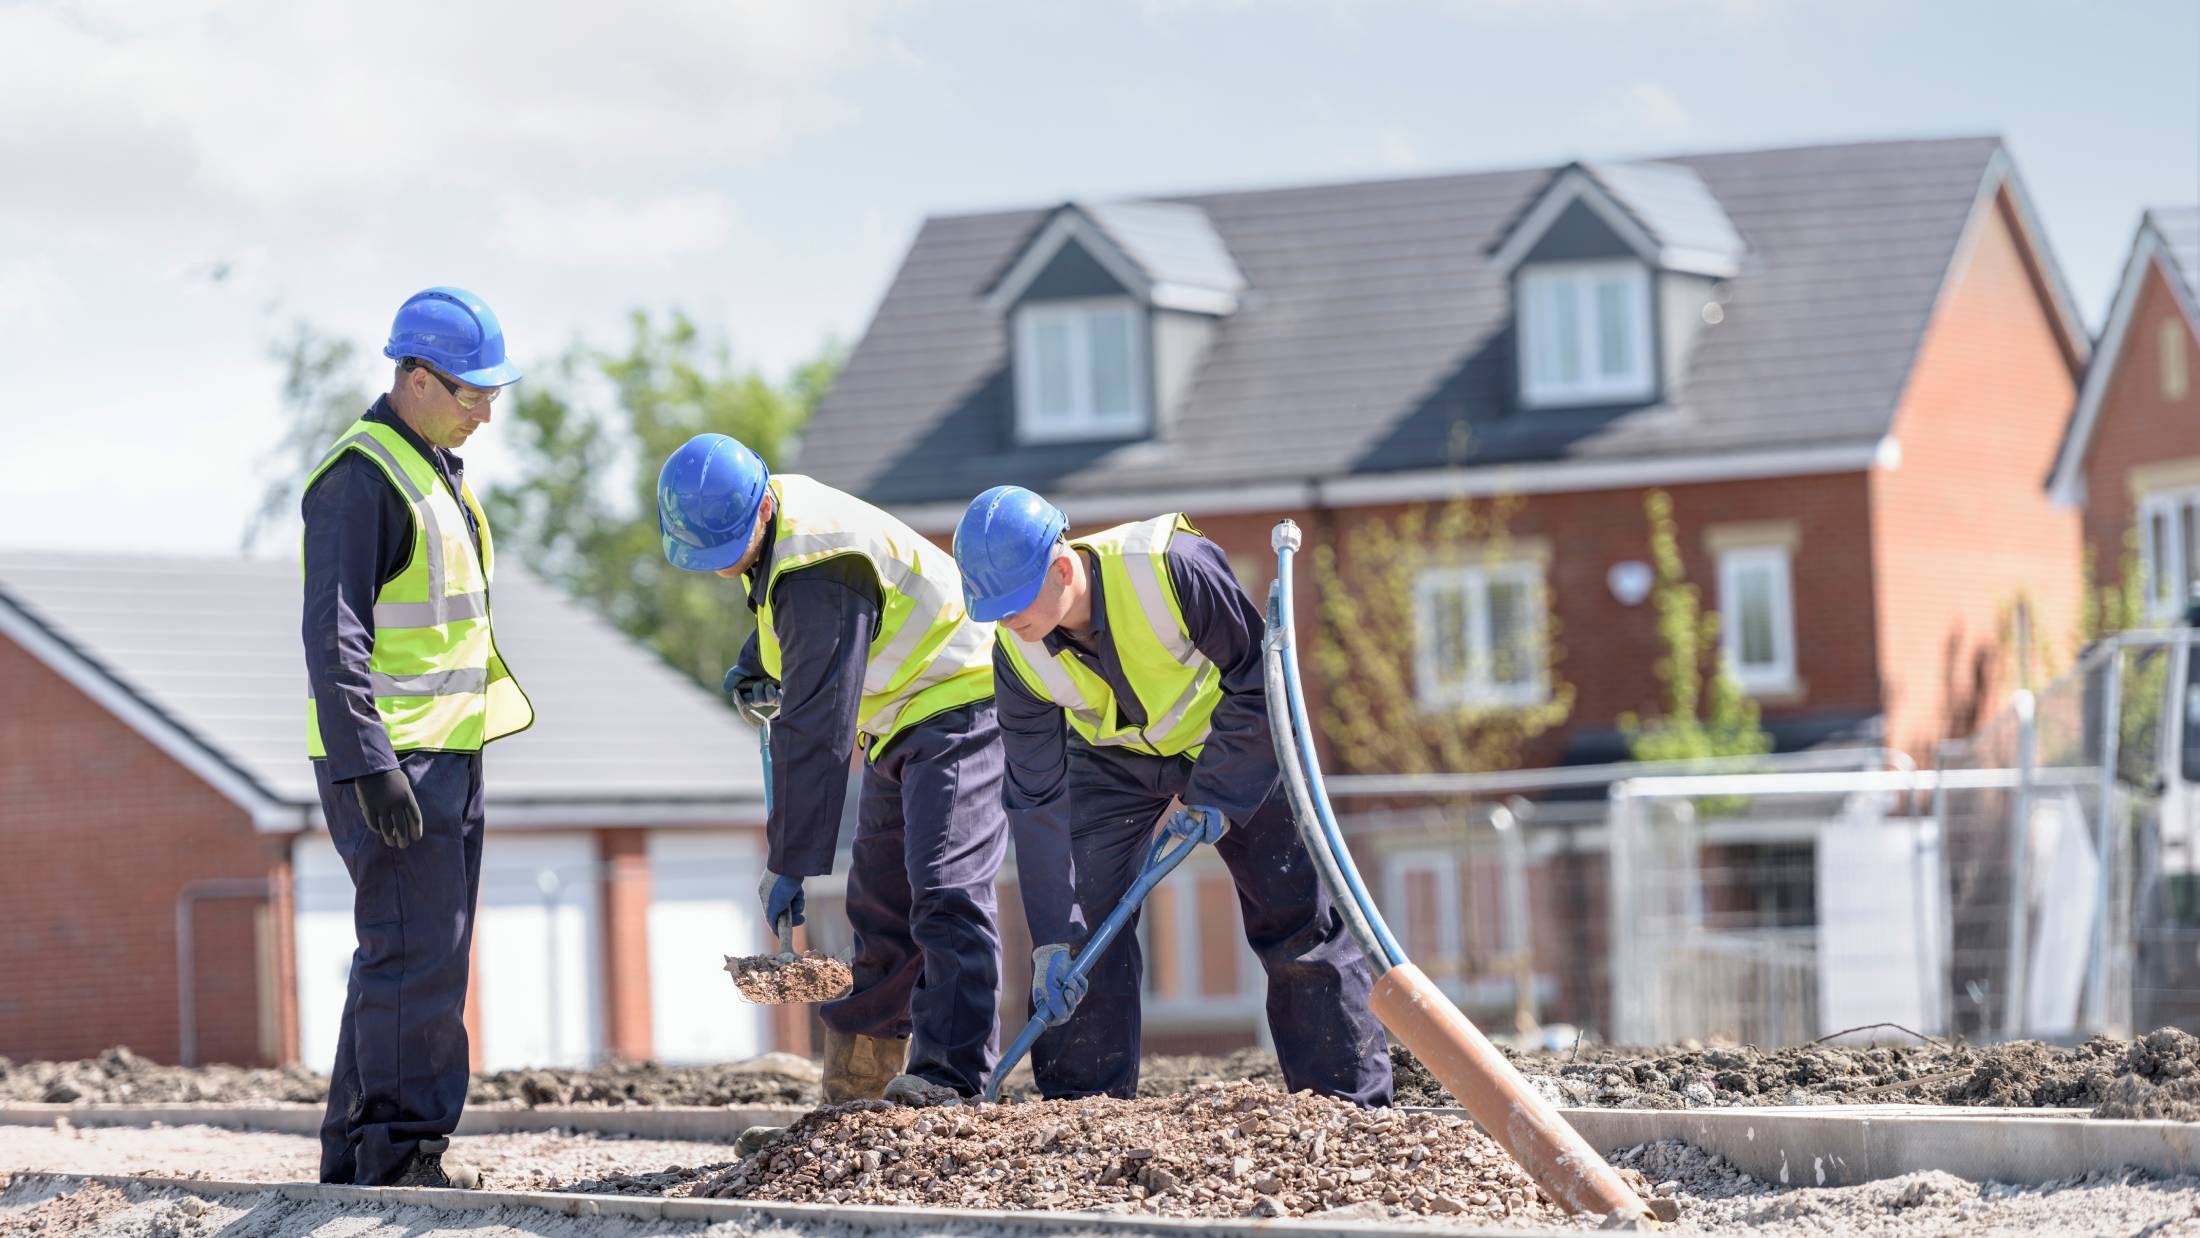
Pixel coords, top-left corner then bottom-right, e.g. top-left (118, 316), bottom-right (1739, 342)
top-left (312, 752), bottom-right (482, 1185)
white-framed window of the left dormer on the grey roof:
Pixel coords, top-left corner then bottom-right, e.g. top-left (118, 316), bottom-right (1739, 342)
top-left (1014, 297), bottom-right (1153, 442)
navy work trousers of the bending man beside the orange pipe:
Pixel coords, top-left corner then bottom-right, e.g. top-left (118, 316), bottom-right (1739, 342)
top-left (1032, 743), bottom-right (1390, 1106)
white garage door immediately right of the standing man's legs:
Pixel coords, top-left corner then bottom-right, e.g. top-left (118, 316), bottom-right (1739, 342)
top-left (473, 829), bottom-right (605, 1071)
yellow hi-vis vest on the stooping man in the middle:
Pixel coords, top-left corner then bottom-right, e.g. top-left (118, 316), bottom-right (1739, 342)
top-left (757, 473), bottom-right (992, 754)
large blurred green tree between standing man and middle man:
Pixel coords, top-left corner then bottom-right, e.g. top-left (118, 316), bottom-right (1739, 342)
top-left (482, 312), bottom-right (843, 688)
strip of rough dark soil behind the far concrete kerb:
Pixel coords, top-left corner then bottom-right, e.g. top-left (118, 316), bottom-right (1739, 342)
top-left (0, 1027), bottom-right (2200, 1121)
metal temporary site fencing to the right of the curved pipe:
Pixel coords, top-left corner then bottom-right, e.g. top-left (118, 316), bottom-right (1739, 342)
top-left (1331, 631), bottom-right (2200, 1044)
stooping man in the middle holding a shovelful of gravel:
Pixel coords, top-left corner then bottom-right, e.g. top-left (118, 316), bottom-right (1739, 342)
top-left (658, 433), bottom-right (1008, 1104)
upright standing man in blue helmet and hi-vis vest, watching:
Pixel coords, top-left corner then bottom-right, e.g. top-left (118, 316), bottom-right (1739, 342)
top-left (304, 288), bottom-right (535, 1187)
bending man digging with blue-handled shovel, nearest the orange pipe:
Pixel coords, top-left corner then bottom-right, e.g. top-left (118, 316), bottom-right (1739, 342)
top-left (955, 486), bottom-right (1390, 1106)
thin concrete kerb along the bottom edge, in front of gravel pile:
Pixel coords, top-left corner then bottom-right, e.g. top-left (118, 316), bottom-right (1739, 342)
top-left (30, 1174), bottom-right (1562, 1238)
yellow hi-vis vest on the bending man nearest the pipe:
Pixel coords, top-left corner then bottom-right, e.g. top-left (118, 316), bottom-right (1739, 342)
top-left (1001, 512), bottom-right (1223, 756)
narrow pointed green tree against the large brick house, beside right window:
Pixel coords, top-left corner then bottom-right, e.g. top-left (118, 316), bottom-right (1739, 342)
top-left (1619, 490), bottom-right (1773, 761)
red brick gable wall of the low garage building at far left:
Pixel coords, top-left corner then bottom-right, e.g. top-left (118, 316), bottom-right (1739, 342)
top-left (0, 638), bottom-right (295, 1062)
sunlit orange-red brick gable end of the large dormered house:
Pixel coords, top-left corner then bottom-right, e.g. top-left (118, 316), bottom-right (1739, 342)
top-left (1870, 186), bottom-right (2081, 761)
